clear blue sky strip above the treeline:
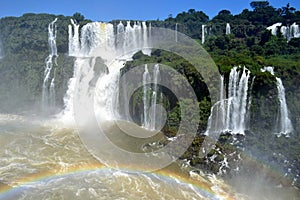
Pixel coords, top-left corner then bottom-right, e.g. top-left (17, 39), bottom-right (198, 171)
top-left (0, 0), bottom-right (300, 21)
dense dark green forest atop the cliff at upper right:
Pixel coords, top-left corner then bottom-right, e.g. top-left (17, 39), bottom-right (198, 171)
top-left (151, 1), bottom-right (300, 70)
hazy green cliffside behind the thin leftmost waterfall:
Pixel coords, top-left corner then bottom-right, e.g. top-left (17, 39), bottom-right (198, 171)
top-left (0, 13), bottom-right (88, 112)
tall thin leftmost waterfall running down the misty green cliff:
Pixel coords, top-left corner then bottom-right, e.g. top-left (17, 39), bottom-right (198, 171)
top-left (42, 18), bottom-right (58, 111)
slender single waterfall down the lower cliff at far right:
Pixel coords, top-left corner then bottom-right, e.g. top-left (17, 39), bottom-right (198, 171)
top-left (261, 66), bottom-right (293, 136)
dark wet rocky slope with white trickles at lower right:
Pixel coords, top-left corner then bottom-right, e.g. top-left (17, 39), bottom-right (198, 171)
top-left (162, 125), bottom-right (300, 187)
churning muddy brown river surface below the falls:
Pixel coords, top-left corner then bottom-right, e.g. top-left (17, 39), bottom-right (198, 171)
top-left (0, 114), bottom-right (298, 200)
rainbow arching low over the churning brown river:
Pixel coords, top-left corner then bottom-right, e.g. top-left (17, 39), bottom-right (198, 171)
top-left (0, 162), bottom-right (235, 200)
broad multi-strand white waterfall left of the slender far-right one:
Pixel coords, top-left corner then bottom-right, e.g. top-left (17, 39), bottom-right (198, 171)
top-left (205, 67), bottom-right (250, 135)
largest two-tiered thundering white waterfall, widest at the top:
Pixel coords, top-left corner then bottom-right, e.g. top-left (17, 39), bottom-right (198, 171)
top-left (62, 21), bottom-right (151, 123)
